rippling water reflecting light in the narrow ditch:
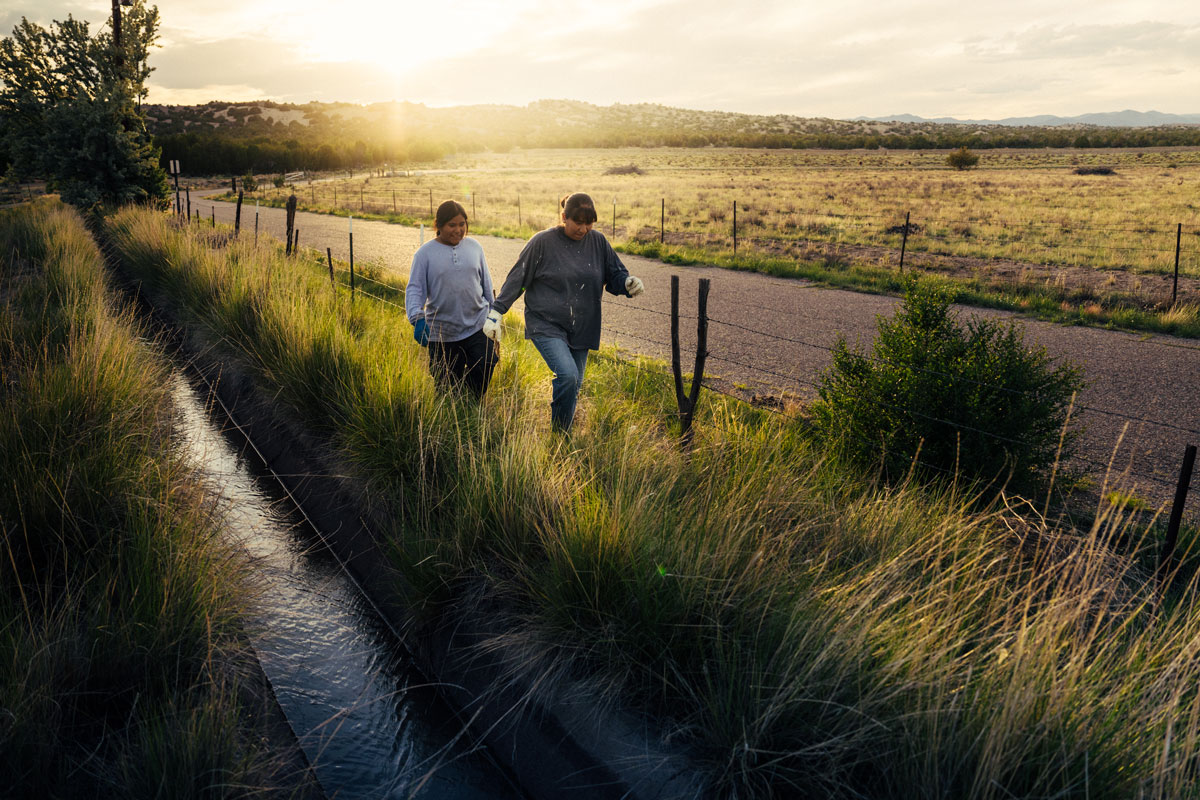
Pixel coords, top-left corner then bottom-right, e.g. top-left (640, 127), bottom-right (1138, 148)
top-left (173, 373), bottom-right (522, 800)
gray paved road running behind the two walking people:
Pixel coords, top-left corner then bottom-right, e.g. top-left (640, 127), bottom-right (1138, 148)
top-left (192, 194), bottom-right (1200, 518)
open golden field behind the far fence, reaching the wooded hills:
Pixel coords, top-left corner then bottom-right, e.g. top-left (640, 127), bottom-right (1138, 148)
top-left (241, 149), bottom-right (1200, 277)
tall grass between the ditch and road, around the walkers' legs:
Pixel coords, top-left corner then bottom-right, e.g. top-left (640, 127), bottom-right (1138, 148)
top-left (109, 211), bottom-right (1200, 799)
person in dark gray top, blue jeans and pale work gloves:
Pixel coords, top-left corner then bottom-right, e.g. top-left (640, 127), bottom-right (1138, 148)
top-left (484, 192), bottom-right (643, 433)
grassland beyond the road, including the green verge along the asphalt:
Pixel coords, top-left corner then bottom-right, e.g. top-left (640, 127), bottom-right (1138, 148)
top-left (223, 149), bottom-right (1200, 337)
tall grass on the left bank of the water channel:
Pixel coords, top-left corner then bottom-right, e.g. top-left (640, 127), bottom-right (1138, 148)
top-left (0, 196), bottom-right (278, 798)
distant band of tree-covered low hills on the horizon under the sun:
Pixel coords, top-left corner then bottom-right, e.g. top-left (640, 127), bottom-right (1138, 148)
top-left (154, 124), bottom-right (1200, 175)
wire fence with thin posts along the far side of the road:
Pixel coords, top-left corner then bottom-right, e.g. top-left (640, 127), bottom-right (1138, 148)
top-left (236, 179), bottom-right (1200, 308)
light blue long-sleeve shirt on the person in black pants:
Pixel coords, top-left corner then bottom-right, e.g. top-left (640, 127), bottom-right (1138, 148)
top-left (404, 236), bottom-right (492, 342)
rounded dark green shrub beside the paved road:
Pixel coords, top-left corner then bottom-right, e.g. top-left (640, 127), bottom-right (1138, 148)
top-left (814, 281), bottom-right (1084, 491)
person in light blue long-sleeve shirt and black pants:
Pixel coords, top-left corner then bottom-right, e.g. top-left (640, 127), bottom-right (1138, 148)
top-left (404, 200), bottom-right (499, 399)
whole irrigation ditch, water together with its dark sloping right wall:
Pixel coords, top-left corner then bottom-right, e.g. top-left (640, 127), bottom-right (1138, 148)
top-left (105, 226), bottom-right (703, 800)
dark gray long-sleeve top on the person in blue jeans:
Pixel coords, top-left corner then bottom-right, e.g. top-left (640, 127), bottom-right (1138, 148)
top-left (492, 227), bottom-right (629, 350)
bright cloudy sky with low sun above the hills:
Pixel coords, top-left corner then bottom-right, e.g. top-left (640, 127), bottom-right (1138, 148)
top-left (9, 0), bottom-right (1200, 119)
